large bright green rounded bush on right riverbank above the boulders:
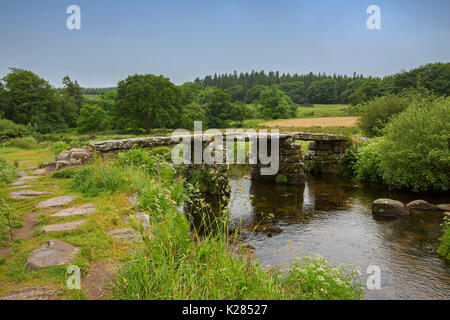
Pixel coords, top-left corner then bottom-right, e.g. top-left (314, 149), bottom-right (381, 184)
top-left (379, 97), bottom-right (450, 191)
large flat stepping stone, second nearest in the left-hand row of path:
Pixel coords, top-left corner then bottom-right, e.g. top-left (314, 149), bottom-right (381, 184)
top-left (25, 240), bottom-right (80, 270)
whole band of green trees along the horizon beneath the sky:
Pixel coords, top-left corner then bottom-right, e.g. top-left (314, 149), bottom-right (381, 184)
top-left (0, 63), bottom-right (450, 133)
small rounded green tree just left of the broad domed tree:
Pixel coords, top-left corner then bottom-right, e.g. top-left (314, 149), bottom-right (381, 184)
top-left (77, 104), bottom-right (109, 133)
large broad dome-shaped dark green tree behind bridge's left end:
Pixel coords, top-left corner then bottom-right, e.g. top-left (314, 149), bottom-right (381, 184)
top-left (114, 74), bottom-right (182, 130)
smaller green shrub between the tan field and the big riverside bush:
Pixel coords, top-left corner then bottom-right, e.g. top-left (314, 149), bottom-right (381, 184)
top-left (359, 95), bottom-right (408, 137)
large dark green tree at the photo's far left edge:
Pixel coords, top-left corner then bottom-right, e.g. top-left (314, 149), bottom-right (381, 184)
top-left (2, 68), bottom-right (67, 133)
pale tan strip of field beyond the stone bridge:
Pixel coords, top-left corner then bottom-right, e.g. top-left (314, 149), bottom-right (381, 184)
top-left (261, 117), bottom-right (358, 128)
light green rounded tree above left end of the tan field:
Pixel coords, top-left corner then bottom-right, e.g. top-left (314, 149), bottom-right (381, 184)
top-left (260, 86), bottom-right (297, 119)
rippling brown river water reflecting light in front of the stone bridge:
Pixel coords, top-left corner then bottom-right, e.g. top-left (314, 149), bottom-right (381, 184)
top-left (229, 174), bottom-right (450, 299)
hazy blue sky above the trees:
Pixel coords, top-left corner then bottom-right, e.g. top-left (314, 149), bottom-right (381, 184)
top-left (0, 0), bottom-right (450, 87)
